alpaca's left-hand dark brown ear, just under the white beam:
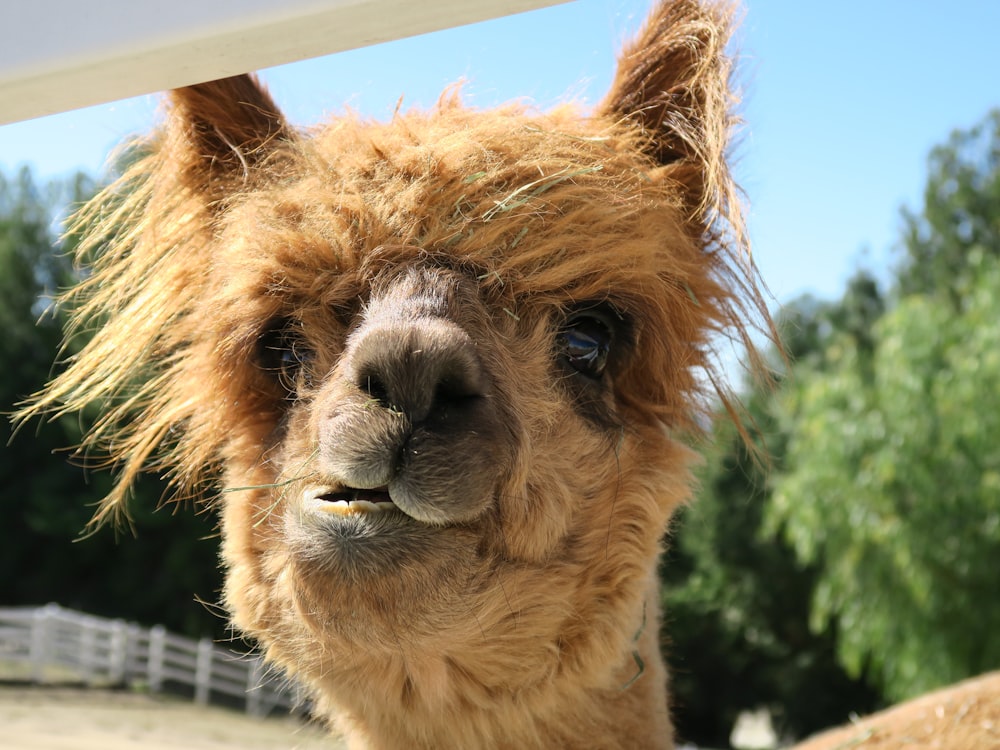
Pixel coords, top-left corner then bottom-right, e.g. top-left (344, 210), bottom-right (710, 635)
top-left (163, 75), bottom-right (293, 207)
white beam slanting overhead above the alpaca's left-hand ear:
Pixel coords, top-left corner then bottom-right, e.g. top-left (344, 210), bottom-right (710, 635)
top-left (0, 0), bottom-right (565, 124)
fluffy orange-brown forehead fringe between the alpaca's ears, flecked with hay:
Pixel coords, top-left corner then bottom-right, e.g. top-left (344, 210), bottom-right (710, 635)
top-left (221, 99), bottom-right (753, 330)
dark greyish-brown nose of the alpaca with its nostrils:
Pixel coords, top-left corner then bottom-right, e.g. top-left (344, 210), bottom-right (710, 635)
top-left (349, 318), bottom-right (484, 424)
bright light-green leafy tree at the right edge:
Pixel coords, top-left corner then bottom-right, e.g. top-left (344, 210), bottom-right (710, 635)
top-left (768, 113), bottom-right (1000, 700)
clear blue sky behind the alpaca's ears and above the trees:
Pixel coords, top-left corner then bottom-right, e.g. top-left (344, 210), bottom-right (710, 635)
top-left (0, 0), bottom-right (1000, 302)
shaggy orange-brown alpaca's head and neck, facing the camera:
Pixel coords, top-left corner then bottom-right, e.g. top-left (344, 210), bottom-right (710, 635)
top-left (25, 0), bottom-right (766, 747)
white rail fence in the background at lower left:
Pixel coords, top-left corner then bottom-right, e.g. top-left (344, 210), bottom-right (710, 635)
top-left (0, 604), bottom-right (304, 716)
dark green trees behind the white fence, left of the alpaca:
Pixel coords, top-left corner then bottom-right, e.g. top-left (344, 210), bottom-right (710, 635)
top-left (0, 169), bottom-right (225, 636)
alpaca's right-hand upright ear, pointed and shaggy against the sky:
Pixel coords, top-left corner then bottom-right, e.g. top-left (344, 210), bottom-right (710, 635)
top-left (598, 0), bottom-right (735, 217)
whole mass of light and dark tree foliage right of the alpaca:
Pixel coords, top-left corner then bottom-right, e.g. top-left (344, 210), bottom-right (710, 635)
top-left (663, 112), bottom-right (1000, 746)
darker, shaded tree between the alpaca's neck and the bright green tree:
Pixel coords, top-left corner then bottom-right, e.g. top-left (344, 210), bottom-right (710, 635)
top-left (661, 296), bottom-right (879, 747)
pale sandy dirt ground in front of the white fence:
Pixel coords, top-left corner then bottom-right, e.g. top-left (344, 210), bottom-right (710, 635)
top-left (0, 685), bottom-right (344, 750)
